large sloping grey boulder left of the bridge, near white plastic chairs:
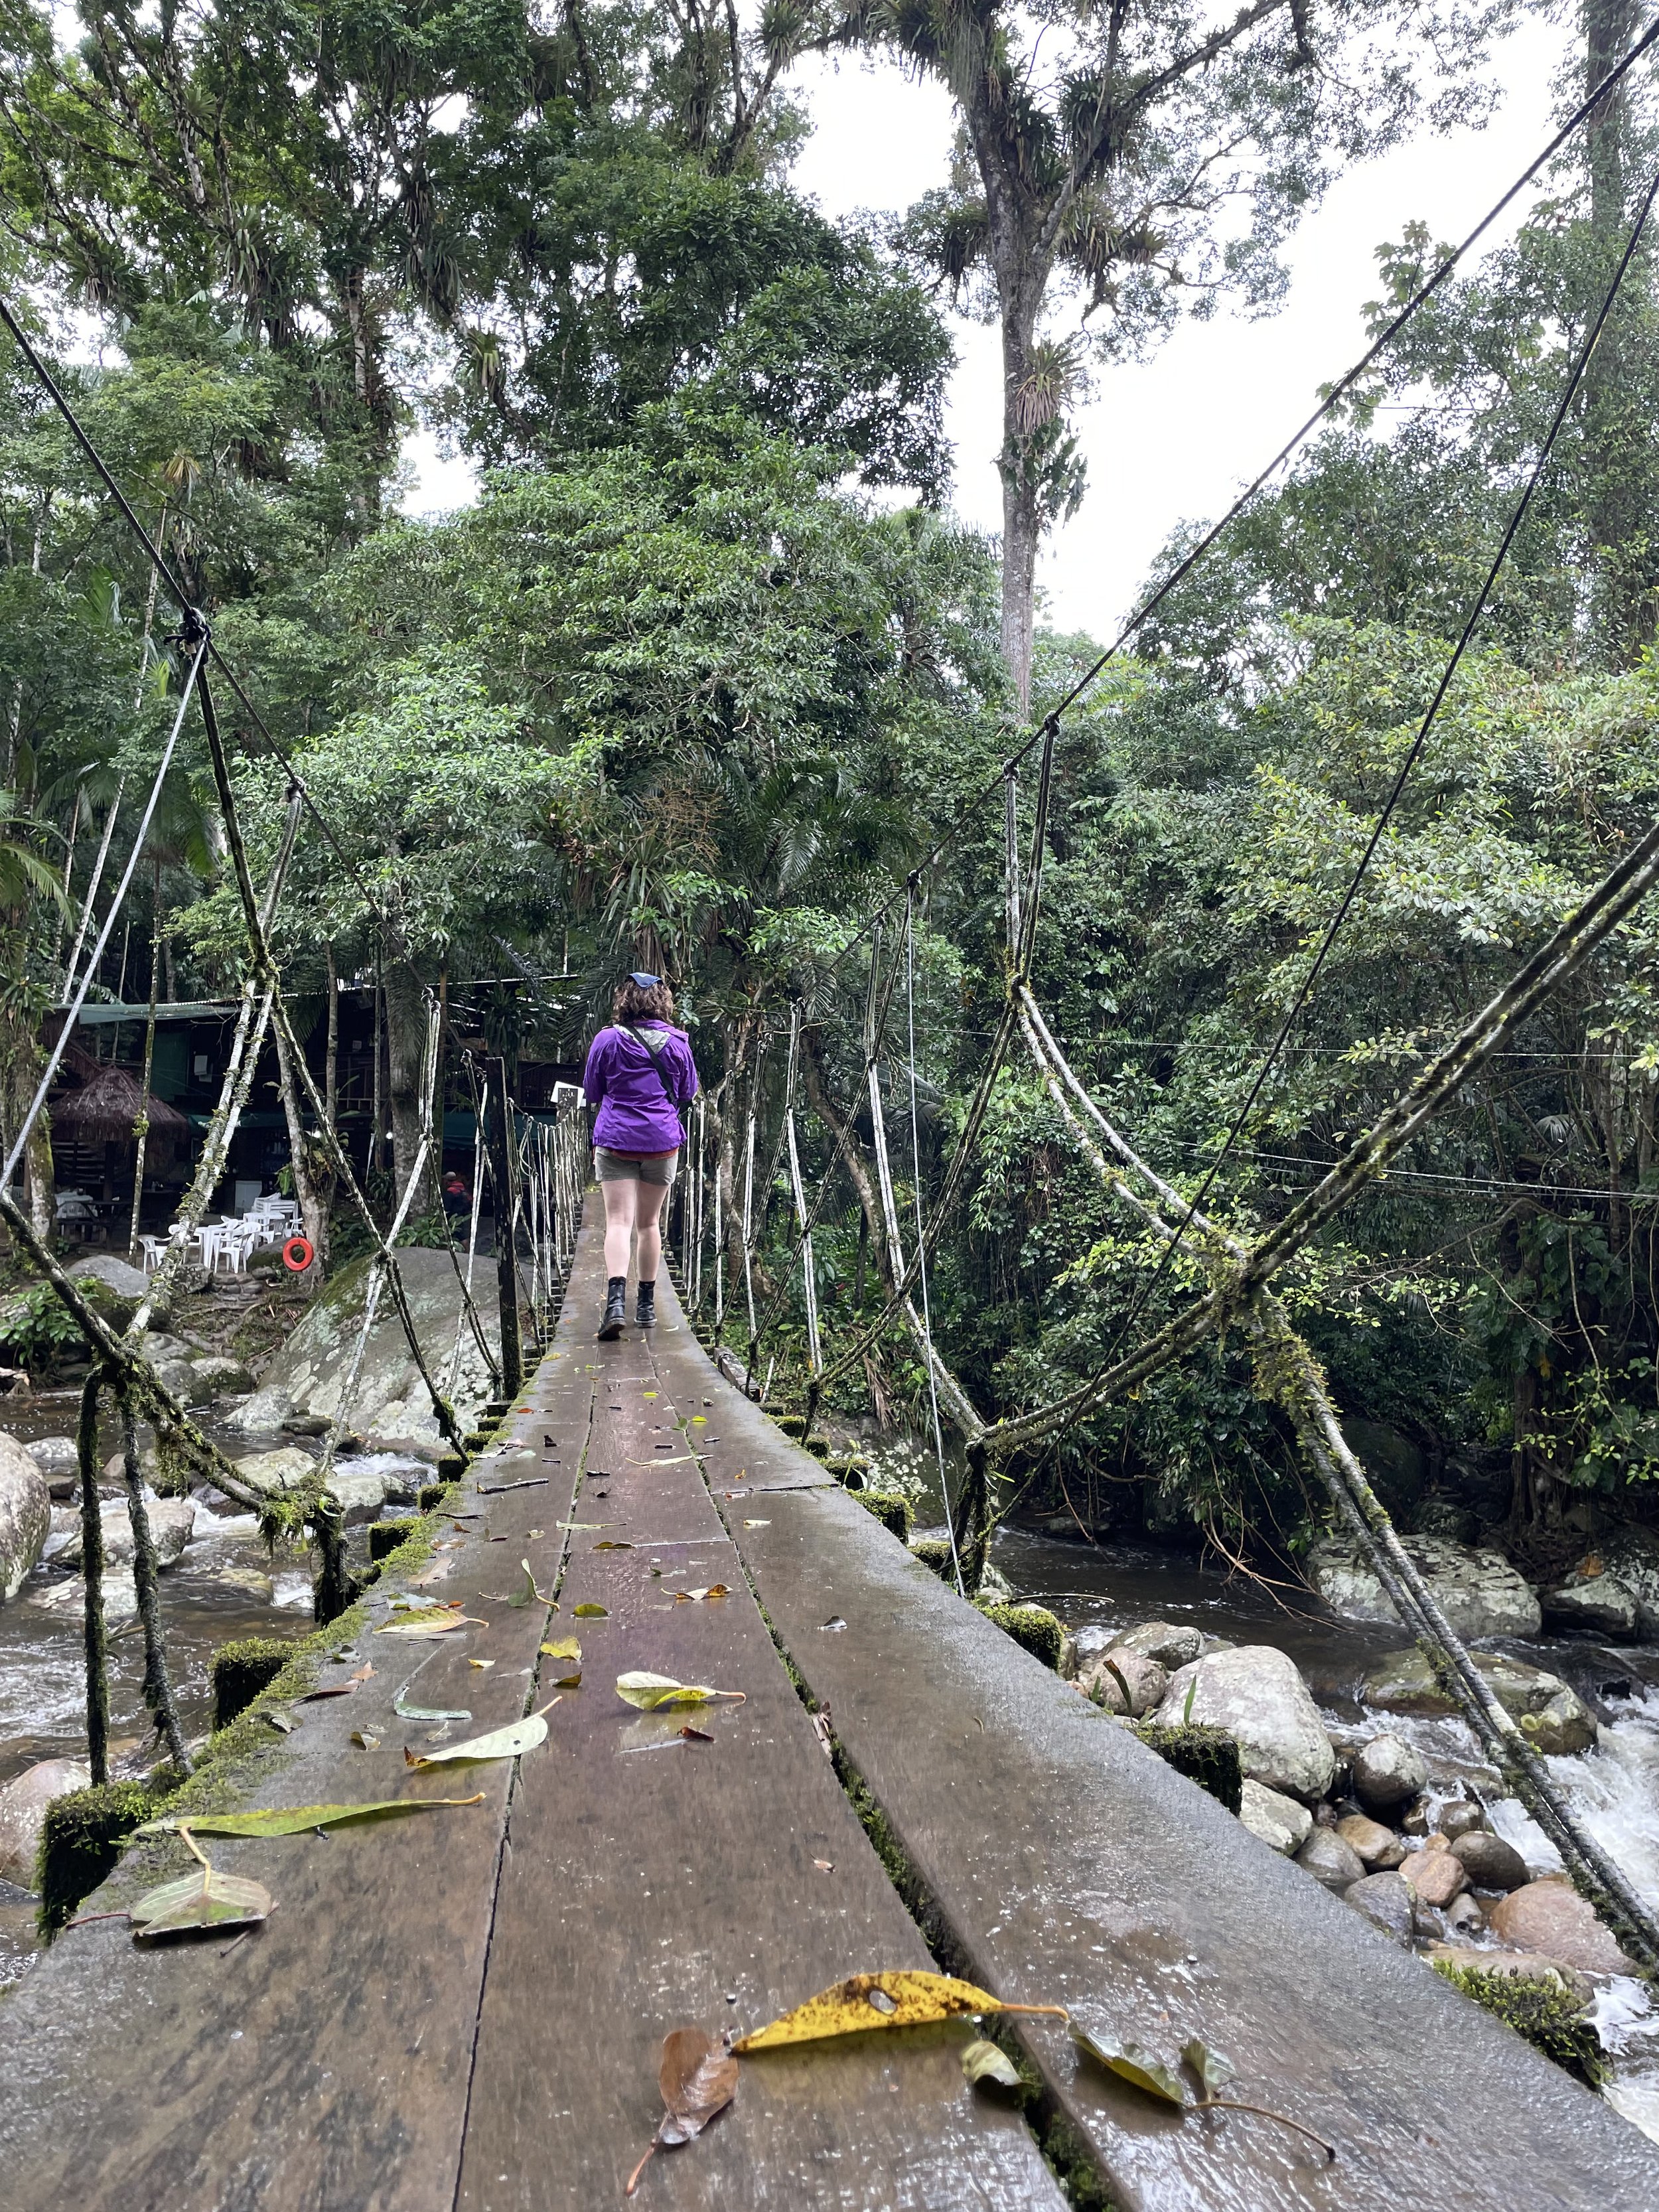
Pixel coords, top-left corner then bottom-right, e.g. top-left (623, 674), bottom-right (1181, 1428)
top-left (250, 1245), bottom-right (511, 1440)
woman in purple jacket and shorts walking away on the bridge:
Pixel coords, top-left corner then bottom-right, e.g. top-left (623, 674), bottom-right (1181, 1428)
top-left (582, 974), bottom-right (697, 1343)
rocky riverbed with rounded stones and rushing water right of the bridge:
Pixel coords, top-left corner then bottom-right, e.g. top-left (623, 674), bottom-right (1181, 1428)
top-left (995, 1528), bottom-right (1659, 2139)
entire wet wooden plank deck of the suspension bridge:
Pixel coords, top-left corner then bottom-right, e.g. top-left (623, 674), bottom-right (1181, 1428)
top-left (0, 1232), bottom-right (1659, 2212)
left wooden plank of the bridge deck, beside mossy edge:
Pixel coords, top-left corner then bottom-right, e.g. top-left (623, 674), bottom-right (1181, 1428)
top-left (0, 1376), bottom-right (591, 2212)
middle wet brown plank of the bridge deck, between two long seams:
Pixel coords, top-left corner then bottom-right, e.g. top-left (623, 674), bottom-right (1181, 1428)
top-left (458, 1230), bottom-right (1062, 2212)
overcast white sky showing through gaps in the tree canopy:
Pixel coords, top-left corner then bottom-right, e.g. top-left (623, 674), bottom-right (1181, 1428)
top-left (409, 15), bottom-right (1566, 637)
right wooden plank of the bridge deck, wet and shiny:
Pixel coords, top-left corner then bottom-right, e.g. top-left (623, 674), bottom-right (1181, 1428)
top-left (670, 1291), bottom-right (1659, 2212)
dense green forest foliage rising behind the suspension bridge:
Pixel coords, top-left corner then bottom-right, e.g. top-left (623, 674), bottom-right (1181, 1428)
top-left (0, 0), bottom-right (1659, 1584)
